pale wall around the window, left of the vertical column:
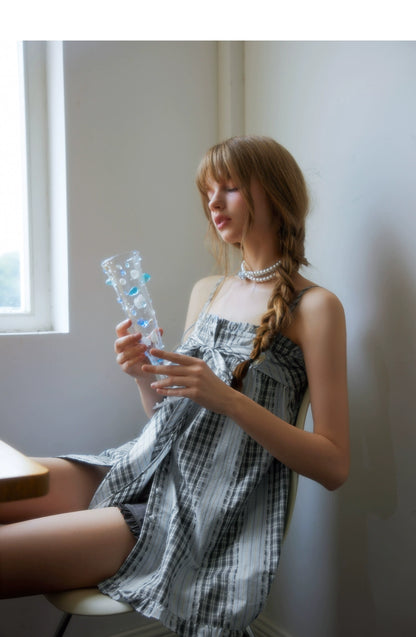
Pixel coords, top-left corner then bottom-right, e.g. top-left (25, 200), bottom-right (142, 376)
top-left (0, 42), bottom-right (218, 637)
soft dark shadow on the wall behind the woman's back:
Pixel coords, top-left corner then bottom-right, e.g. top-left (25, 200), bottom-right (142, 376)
top-left (337, 224), bottom-right (416, 637)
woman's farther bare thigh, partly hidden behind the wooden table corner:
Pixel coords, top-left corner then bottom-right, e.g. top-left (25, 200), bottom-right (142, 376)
top-left (0, 458), bottom-right (108, 524)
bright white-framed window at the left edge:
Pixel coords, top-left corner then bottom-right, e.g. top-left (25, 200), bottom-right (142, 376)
top-left (0, 42), bottom-right (68, 333)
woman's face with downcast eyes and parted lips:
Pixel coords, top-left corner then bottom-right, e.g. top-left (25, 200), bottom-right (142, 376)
top-left (207, 180), bottom-right (274, 245)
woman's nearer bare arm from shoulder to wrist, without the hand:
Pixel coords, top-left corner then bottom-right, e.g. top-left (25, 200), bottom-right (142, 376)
top-left (224, 290), bottom-right (349, 489)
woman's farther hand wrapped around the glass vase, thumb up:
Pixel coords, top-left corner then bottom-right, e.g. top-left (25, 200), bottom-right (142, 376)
top-left (114, 319), bottom-right (163, 380)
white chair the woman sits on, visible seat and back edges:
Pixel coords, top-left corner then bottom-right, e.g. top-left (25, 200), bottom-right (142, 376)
top-left (45, 389), bottom-right (310, 637)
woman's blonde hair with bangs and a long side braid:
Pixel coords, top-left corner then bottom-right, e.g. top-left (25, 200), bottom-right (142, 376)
top-left (196, 136), bottom-right (309, 389)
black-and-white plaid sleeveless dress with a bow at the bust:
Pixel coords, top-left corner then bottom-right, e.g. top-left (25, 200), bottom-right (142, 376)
top-left (65, 306), bottom-right (307, 637)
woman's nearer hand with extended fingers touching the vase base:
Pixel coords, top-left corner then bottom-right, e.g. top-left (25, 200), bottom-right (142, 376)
top-left (143, 349), bottom-right (237, 414)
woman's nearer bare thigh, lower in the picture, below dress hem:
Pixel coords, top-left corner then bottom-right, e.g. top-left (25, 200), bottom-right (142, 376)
top-left (0, 507), bottom-right (136, 598)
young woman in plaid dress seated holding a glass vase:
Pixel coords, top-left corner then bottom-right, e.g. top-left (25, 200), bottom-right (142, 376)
top-left (0, 137), bottom-right (349, 636)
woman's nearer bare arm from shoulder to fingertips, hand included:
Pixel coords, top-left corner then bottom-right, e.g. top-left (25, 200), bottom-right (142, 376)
top-left (143, 289), bottom-right (349, 489)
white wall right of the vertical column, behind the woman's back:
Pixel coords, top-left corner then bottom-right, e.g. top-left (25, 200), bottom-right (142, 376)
top-left (245, 42), bottom-right (416, 637)
